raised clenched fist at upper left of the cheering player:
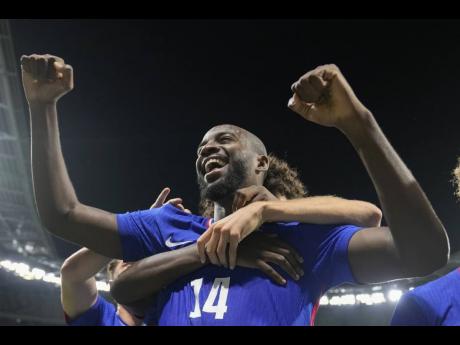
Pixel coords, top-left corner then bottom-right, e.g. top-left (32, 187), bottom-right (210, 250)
top-left (21, 54), bottom-right (73, 104)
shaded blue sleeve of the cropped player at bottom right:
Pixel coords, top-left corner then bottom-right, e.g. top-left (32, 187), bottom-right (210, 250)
top-left (391, 292), bottom-right (434, 326)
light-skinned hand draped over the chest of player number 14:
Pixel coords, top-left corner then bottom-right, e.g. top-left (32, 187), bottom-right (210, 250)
top-left (197, 201), bottom-right (265, 269)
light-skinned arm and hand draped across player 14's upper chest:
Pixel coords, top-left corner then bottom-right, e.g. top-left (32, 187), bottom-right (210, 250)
top-left (197, 186), bottom-right (382, 268)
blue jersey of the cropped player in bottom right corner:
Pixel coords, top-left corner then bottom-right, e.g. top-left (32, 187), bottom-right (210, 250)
top-left (391, 268), bottom-right (460, 326)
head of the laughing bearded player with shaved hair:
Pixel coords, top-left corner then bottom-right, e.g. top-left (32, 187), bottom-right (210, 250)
top-left (196, 125), bottom-right (269, 201)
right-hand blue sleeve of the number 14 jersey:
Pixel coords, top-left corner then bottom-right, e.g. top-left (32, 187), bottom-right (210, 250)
top-left (313, 225), bottom-right (361, 292)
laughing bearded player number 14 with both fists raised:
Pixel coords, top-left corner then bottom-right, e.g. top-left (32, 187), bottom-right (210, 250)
top-left (22, 55), bottom-right (448, 325)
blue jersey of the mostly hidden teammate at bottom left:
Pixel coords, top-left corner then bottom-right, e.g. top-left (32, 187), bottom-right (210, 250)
top-left (65, 295), bottom-right (127, 326)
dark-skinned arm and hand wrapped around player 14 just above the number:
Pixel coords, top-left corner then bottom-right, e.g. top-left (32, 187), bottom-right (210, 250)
top-left (111, 233), bottom-right (304, 307)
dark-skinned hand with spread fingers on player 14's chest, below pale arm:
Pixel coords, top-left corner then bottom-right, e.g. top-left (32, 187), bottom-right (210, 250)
top-left (236, 232), bottom-right (304, 285)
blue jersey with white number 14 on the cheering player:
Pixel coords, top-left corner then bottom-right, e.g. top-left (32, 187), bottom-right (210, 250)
top-left (117, 204), bottom-right (359, 326)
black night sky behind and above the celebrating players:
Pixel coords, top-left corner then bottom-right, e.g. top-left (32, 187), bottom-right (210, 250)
top-left (7, 19), bottom-right (460, 257)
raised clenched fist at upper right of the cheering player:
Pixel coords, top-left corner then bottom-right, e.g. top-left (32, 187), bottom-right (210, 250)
top-left (288, 65), bottom-right (369, 130)
